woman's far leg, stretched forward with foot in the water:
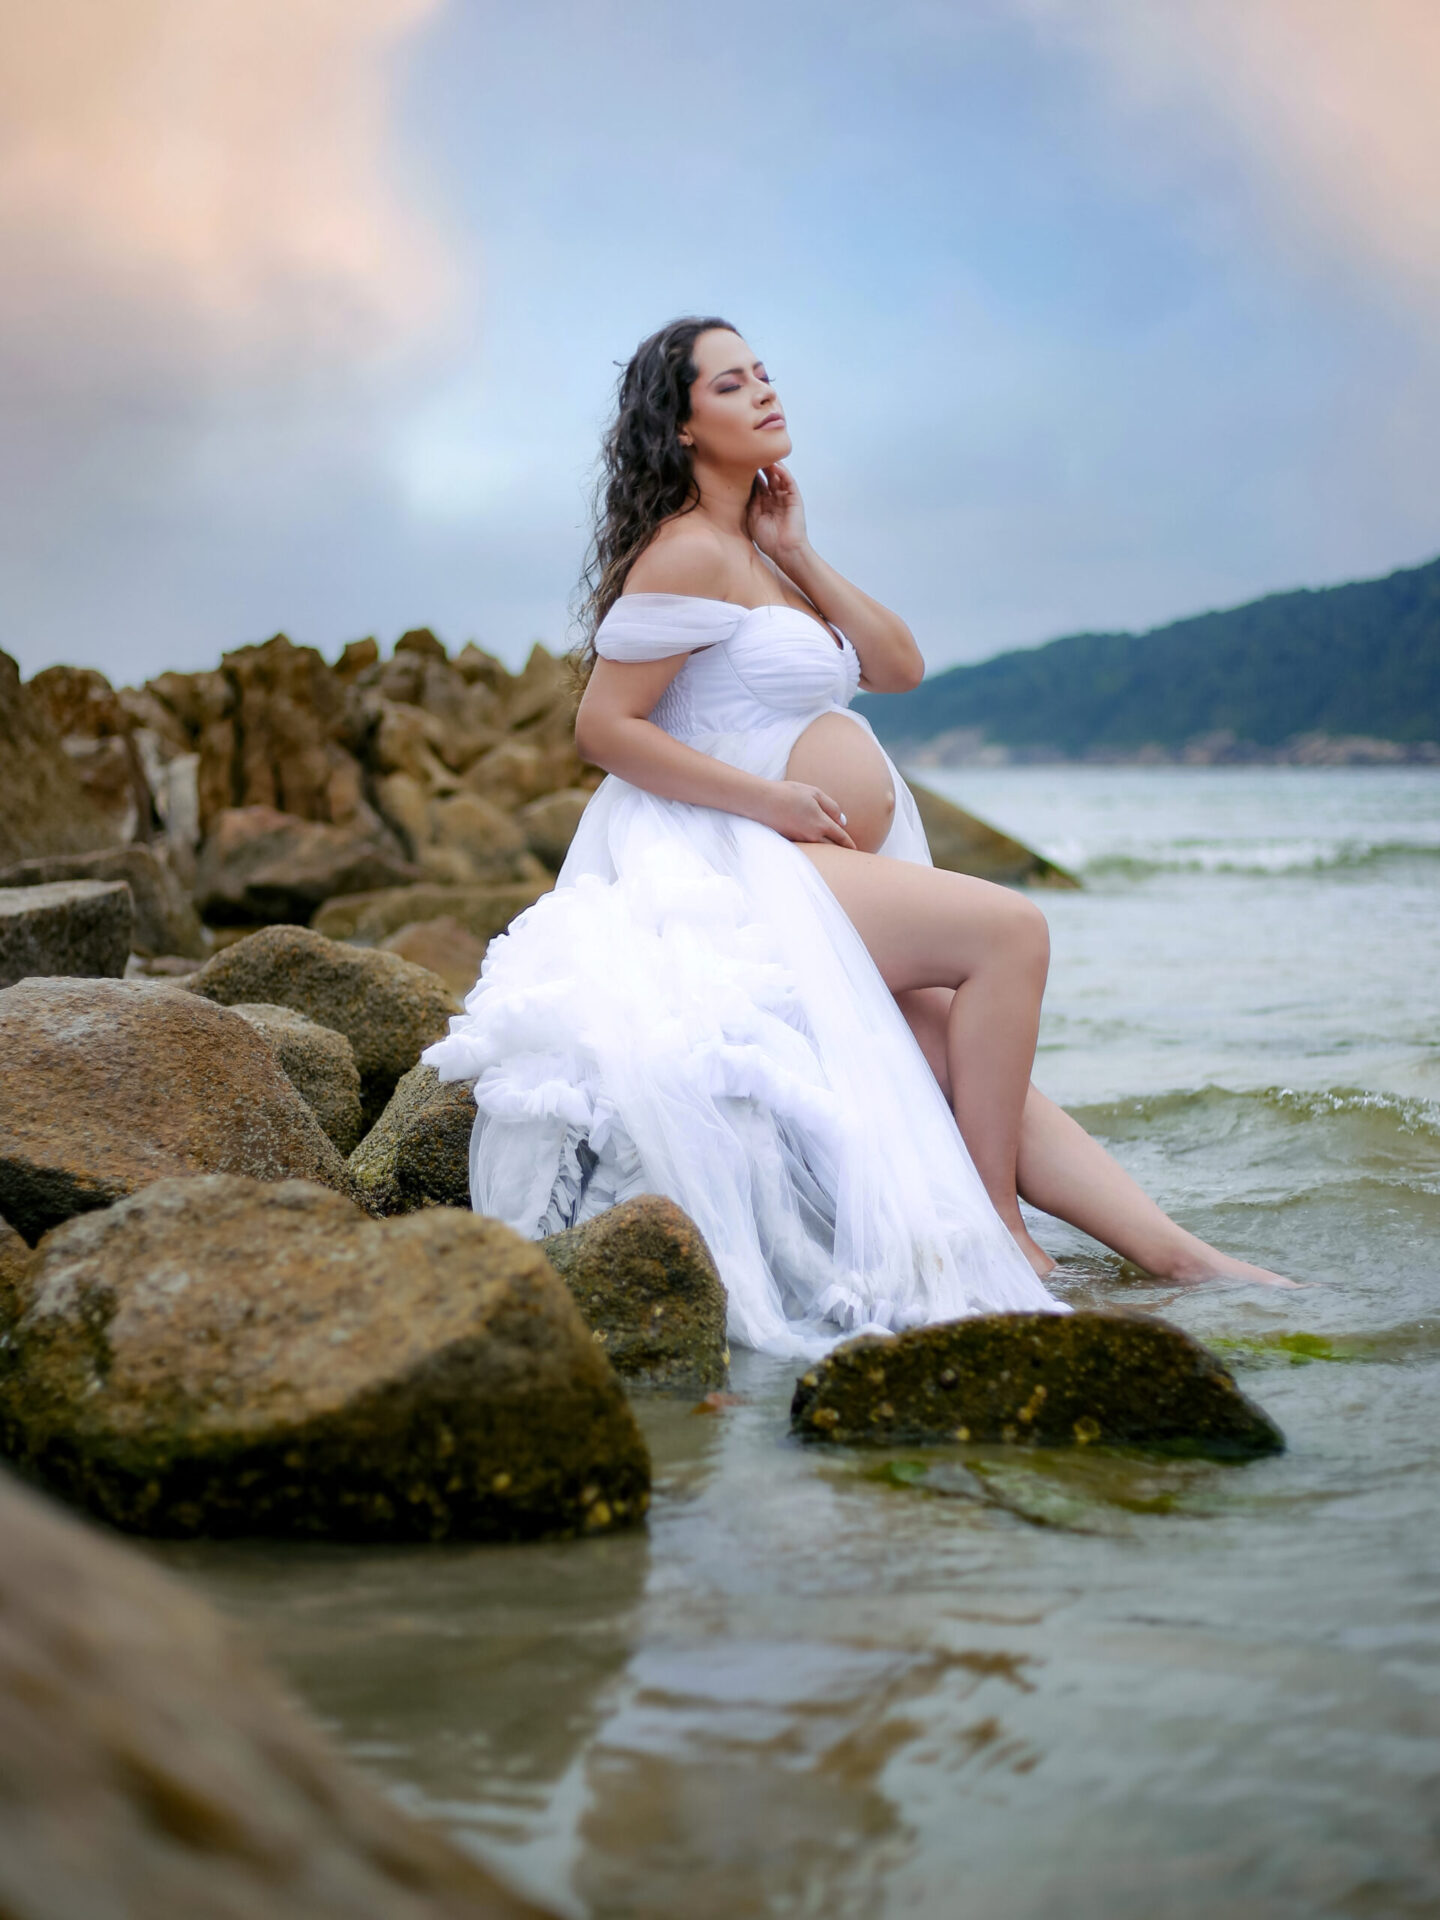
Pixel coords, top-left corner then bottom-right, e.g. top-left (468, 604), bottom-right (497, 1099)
top-left (897, 987), bottom-right (1294, 1286)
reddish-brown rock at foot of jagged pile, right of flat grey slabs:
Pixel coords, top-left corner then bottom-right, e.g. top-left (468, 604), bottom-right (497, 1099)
top-left (196, 806), bottom-right (420, 925)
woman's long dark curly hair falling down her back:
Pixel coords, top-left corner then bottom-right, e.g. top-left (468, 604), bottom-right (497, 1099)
top-left (576, 313), bottom-right (739, 676)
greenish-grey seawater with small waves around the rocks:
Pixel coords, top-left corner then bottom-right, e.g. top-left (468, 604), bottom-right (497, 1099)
top-left (165, 768), bottom-right (1440, 1920)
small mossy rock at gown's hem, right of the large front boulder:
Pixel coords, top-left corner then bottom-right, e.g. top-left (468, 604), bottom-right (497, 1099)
top-left (540, 1194), bottom-right (730, 1392)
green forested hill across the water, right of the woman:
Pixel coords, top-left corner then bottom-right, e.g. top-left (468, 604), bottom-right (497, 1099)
top-left (856, 559), bottom-right (1440, 756)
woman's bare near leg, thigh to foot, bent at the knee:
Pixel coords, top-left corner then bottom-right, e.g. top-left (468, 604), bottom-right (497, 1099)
top-left (801, 845), bottom-right (1054, 1273)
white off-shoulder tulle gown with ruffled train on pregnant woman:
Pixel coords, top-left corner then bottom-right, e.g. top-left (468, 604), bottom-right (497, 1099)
top-left (424, 593), bottom-right (1058, 1357)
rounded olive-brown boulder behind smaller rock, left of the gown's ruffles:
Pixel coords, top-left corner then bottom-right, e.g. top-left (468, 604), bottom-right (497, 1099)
top-left (184, 927), bottom-right (459, 1127)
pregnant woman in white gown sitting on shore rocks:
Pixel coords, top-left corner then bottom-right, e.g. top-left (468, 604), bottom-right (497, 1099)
top-left (424, 319), bottom-right (1288, 1356)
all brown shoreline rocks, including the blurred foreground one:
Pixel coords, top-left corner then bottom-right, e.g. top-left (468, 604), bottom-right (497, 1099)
top-left (0, 632), bottom-right (1283, 1916)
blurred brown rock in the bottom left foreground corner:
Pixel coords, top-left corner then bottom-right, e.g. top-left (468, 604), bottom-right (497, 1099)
top-left (0, 1475), bottom-right (540, 1920)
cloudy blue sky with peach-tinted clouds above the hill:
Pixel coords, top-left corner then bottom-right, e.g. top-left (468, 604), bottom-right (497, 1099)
top-left (0, 0), bottom-right (1440, 680)
